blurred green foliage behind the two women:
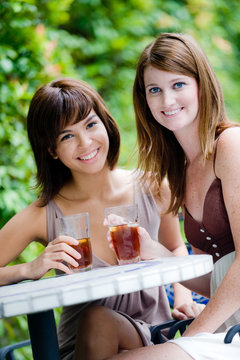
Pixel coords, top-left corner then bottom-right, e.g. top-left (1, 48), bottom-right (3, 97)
top-left (0, 0), bottom-right (240, 359)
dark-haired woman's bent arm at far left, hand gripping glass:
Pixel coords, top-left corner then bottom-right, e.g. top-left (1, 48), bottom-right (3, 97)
top-left (0, 203), bottom-right (79, 285)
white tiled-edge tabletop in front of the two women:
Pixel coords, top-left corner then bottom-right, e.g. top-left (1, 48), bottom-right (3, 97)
top-left (0, 255), bottom-right (213, 318)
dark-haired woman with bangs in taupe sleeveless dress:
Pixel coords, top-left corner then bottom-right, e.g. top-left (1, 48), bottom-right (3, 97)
top-left (0, 79), bottom-right (201, 360)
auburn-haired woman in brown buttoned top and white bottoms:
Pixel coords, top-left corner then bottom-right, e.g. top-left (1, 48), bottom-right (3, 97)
top-left (107, 33), bottom-right (240, 360)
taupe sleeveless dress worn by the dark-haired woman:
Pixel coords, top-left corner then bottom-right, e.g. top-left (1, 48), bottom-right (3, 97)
top-left (46, 178), bottom-right (171, 360)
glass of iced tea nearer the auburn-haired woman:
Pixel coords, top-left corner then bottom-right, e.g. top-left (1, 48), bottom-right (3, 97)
top-left (104, 204), bottom-right (140, 265)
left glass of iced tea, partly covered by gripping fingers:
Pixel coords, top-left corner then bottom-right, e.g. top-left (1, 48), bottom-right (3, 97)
top-left (56, 213), bottom-right (92, 272)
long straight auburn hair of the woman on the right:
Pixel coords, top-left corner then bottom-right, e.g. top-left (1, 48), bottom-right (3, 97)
top-left (133, 33), bottom-right (233, 214)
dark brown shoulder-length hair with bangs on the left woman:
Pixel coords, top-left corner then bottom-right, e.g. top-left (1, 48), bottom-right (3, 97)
top-left (27, 78), bottom-right (120, 206)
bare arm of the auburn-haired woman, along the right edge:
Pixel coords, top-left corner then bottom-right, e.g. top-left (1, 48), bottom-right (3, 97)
top-left (184, 128), bottom-right (240, 336)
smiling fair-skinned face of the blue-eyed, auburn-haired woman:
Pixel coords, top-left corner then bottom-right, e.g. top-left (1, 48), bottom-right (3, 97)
top-left (144, 66), bottom-right (199, 132)
